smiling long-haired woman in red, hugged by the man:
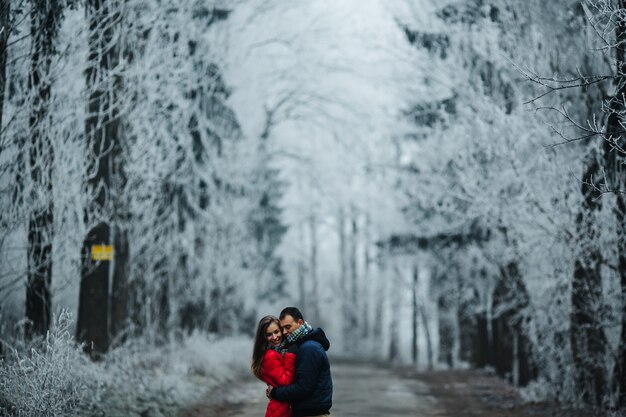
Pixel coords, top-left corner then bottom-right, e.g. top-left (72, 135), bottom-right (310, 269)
top-left (251, 316), bottom-right (296, 417)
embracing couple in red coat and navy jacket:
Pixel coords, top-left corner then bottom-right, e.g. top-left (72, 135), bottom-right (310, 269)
top-left (252, 307), bottom-right (333, 417)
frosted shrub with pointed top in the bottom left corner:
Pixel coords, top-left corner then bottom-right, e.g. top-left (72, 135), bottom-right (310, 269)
top-left (0, 311), bottom-right (98, 417)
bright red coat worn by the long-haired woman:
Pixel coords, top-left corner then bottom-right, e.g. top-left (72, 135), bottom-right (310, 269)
top-left (261, 349), bottom-right (296, 417)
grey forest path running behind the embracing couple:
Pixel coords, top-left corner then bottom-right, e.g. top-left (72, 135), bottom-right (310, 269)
top-left (183, 361), bottom-right (600, 417)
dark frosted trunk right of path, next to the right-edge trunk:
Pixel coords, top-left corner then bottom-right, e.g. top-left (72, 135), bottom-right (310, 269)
top-left (570, 151), bottom-right (606, 405)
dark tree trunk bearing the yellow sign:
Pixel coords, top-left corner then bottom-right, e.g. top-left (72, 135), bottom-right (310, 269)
top-left (76, 0), bottom-right (125, 354)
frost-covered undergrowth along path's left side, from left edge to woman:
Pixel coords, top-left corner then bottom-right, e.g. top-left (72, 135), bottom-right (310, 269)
top-left (0, 311), bottom-right (252, 417)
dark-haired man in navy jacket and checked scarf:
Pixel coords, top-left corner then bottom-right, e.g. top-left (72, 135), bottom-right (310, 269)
top-left (266, 307), bottom-right (333, 417)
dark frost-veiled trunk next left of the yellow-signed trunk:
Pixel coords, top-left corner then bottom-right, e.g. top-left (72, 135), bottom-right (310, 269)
top-left (26, 1), bottom-right (63, 336)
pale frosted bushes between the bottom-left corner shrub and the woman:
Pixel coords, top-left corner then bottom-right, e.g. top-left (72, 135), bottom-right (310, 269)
top-left (101, 332), bottom-right (252, 416)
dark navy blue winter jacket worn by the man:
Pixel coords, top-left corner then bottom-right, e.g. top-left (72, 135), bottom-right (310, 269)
top-left (272, 328), bottom-right (333, 417)
